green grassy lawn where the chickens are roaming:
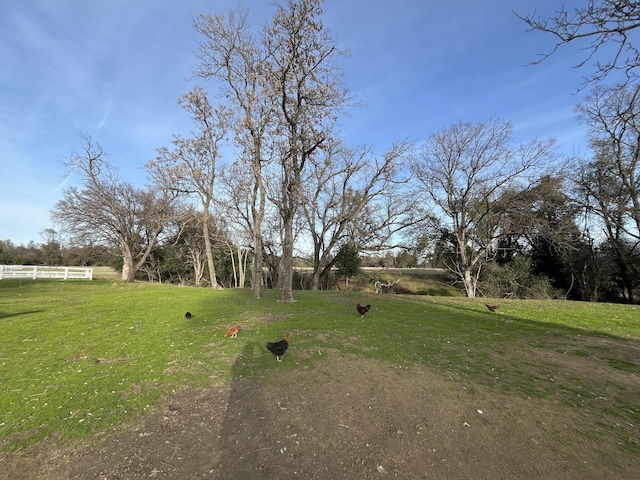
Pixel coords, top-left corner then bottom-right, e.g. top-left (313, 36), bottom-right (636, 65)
top-left (0, 274), bottom-right (640, 452)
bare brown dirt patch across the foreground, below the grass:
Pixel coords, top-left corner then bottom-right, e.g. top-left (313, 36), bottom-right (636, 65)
top-left (0, 353), bottom-right (640, 480)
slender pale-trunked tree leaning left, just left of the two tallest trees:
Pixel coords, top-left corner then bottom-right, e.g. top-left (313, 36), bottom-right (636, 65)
top-left (145, 87), bottom-right (227, 288)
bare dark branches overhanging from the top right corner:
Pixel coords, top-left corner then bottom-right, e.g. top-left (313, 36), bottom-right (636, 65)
top-left (514, 0), bottom-right (640, 87)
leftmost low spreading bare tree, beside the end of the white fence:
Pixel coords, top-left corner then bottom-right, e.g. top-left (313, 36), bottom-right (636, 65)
top-left (51, 135), bottom-right (175, 282)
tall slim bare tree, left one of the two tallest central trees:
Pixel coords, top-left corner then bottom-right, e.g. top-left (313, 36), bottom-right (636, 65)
top-left (194, 9), bottom-right (274, 298)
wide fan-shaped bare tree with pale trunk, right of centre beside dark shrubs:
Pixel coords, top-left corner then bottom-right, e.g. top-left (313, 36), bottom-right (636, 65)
top-left (412, 118), bottom-right (555, 297)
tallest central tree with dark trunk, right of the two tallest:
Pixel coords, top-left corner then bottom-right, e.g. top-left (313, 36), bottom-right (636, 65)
top-left (263, 0), bottom-right (347, 302)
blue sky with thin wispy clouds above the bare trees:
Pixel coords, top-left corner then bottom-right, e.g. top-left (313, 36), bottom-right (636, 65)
top-left (0, 0), bottom-right (587, 245)
